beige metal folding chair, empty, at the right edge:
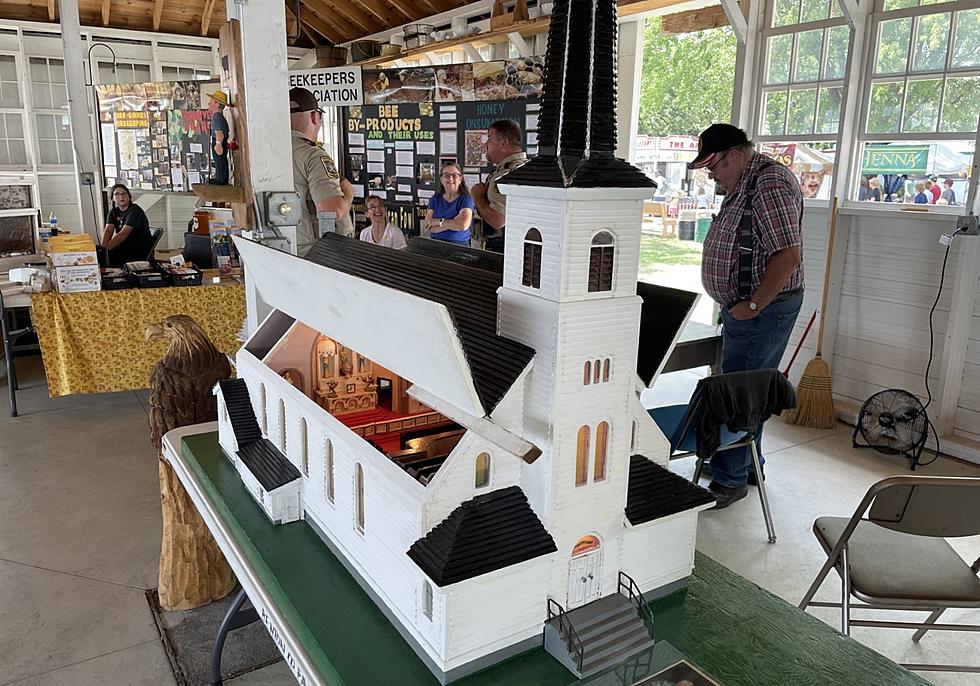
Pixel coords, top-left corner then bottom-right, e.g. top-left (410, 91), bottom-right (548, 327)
top-left (800, 476), bottom-right (980, 673)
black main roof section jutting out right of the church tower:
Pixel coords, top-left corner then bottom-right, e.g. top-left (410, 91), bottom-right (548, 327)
top-left (636, 281), bottom-right (698, 386)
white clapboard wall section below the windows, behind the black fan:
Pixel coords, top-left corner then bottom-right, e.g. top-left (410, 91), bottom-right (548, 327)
top-left (828, 215), bottom-right (957, 404)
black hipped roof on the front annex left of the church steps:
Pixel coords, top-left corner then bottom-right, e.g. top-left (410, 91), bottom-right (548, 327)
top-left (408, 486), bottom-right (558, 586)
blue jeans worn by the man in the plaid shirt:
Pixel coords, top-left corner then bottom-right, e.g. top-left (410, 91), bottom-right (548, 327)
top-left (711, 289), bottom-right (803, 486)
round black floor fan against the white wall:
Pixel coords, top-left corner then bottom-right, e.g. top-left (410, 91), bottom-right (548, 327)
top-left (851, 388), bottom-right (932, 470)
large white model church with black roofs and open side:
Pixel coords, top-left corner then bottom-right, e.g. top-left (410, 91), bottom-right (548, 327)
top-left (215, 0), bottom-right (713, 683)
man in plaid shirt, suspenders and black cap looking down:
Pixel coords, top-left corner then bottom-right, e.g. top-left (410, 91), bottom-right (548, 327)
top-left (688, 124), bottom-right (803, 509)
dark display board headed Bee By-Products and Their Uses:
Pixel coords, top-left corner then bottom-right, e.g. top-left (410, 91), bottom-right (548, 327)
top-left (342, 57), bottom-right (544, 235)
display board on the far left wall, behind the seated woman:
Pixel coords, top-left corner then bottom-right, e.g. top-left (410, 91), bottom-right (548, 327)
top-left (95, 79), bottom-right (220, 192)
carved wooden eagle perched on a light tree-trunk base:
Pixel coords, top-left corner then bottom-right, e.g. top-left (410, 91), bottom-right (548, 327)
top-left (146, 314), bottom-right (236, 610)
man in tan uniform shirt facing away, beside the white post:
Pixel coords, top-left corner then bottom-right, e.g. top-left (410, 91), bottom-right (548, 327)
top-left (289, 88), bottom-right (354, 255)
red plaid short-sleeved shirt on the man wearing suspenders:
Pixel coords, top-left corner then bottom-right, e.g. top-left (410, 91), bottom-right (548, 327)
top-left (701, 153), bottom-right (803, 307)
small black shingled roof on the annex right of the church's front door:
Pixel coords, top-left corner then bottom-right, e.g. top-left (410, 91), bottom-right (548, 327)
top-left (626, 455), bottom-right (715, 526)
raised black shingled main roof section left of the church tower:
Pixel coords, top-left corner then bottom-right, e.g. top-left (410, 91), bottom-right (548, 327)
top-left (306, 233), bottom-right (534, 414)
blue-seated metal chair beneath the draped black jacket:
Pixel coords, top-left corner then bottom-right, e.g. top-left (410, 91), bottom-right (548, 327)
top-left (648, 372), bottom-right (778, 543)
